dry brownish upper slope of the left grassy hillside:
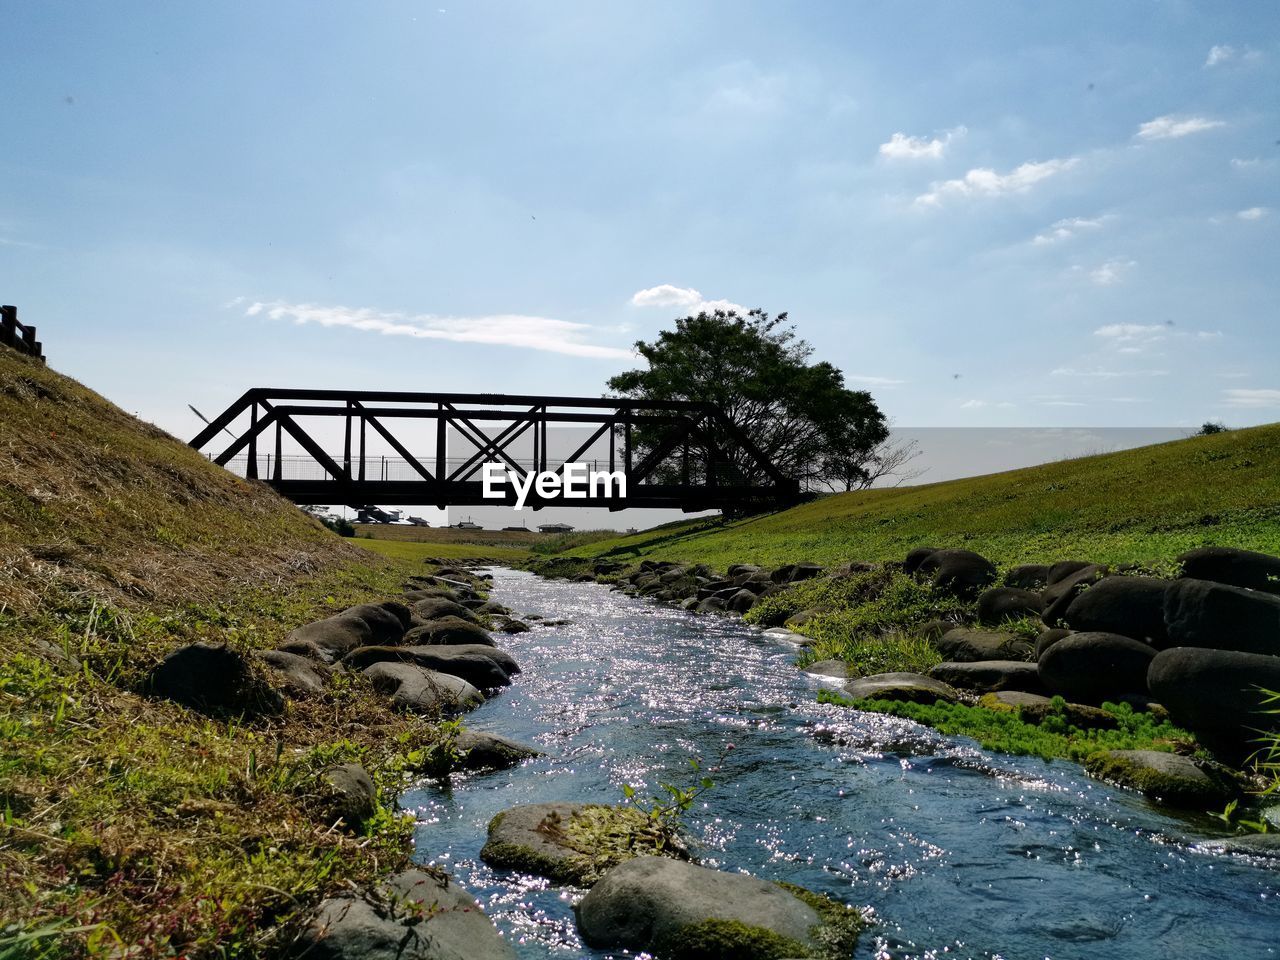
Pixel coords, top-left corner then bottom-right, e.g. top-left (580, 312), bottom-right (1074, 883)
top-left (0, 349), bottom-right (364, 611)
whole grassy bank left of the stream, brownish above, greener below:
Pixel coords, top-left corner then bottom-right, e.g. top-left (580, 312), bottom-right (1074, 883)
top-left (0, 348), bottom-right (460, 960)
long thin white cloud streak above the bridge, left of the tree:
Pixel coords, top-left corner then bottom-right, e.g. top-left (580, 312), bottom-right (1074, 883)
top-left (244, 301), bottom-right (634, 360)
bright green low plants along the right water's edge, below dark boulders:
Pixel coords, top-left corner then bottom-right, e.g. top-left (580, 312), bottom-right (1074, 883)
top-left (818, 690), bottom-right (1194, 760)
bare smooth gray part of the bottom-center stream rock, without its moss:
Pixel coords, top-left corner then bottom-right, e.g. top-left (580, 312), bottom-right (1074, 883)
top-left (575, 856), bottom-right (820, 960)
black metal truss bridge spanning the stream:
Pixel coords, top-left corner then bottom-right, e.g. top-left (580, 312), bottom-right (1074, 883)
top-left (191, 388), bottom-right (800, 513)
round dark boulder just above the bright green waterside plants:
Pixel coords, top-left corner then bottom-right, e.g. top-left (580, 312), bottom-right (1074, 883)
top-left (1039, 634), bottom-right (1156, 703)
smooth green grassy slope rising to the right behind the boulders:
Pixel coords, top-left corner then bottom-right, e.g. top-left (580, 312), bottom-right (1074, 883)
top-left (555, 424), bottom-right (1280, 568)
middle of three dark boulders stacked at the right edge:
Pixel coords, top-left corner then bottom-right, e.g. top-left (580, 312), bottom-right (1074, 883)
top-left (1165, 580), bottom-right (1280, 654)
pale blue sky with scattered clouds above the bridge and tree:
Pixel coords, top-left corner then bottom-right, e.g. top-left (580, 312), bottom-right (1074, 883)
top-left (0, 0), bottom-right (1280, 438)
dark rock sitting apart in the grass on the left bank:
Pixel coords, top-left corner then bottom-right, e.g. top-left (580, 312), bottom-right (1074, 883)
top-left (145, 644), bottom-right (284, 716)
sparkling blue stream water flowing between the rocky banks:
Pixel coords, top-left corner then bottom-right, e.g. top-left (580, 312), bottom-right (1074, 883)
top-left (402, 570), bottom-right (1280, 960)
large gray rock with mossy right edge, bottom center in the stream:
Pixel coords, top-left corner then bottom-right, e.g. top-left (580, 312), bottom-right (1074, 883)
top-left (575, 856), bottom-right (860, 960)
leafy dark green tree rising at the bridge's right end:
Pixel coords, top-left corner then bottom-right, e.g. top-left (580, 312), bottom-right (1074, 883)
top-left (609, 310), bottom-right (888, 489)
